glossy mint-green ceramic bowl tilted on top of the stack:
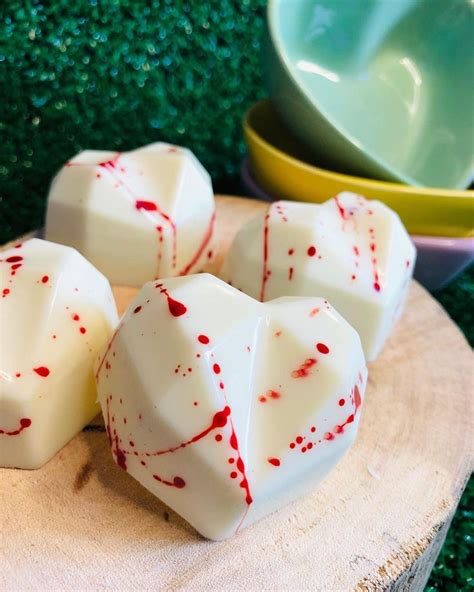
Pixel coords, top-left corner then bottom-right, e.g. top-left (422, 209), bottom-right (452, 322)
top-left (265, 0), bottom-right (474, 188)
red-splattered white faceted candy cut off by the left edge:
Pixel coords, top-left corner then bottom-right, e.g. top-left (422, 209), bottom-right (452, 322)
top-left (0, 239), bottom-right (118, 469)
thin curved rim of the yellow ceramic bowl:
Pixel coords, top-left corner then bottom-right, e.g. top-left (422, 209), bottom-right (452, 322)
top-left (243, 100), bottom-right (474, 206)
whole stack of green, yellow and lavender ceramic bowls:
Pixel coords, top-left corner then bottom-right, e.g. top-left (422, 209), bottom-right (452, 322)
top-left (243, 0), bottom-right (474, 289)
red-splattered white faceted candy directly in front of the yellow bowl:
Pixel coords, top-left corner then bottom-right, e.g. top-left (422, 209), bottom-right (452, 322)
top-left (219, 193), bottom-right (416, 361)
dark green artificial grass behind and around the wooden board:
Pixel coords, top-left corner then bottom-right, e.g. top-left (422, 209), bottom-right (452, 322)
top-left (0, 0), bottom-right (474, 592)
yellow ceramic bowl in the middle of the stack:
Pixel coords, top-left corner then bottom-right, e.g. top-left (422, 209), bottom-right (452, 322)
top-left (243, 100), bottom-right (474, 237)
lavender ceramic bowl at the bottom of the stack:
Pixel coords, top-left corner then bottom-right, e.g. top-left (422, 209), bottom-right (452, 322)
top-left (241, 159), bottom-right (474, 291)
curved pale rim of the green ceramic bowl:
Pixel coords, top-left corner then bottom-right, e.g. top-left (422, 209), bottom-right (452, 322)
top-left (267, 0), bottom-right (472, 191)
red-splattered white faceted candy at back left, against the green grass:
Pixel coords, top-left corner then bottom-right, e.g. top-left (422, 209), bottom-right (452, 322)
top-left (46, 143), bottom-right (216, 288)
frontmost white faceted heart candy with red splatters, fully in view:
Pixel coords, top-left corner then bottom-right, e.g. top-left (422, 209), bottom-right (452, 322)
top-left (96, 274), bottom-right (367, 539)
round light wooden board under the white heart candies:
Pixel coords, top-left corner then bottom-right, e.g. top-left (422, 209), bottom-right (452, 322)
top-left (0, 197), bottom-right (474, 592)
